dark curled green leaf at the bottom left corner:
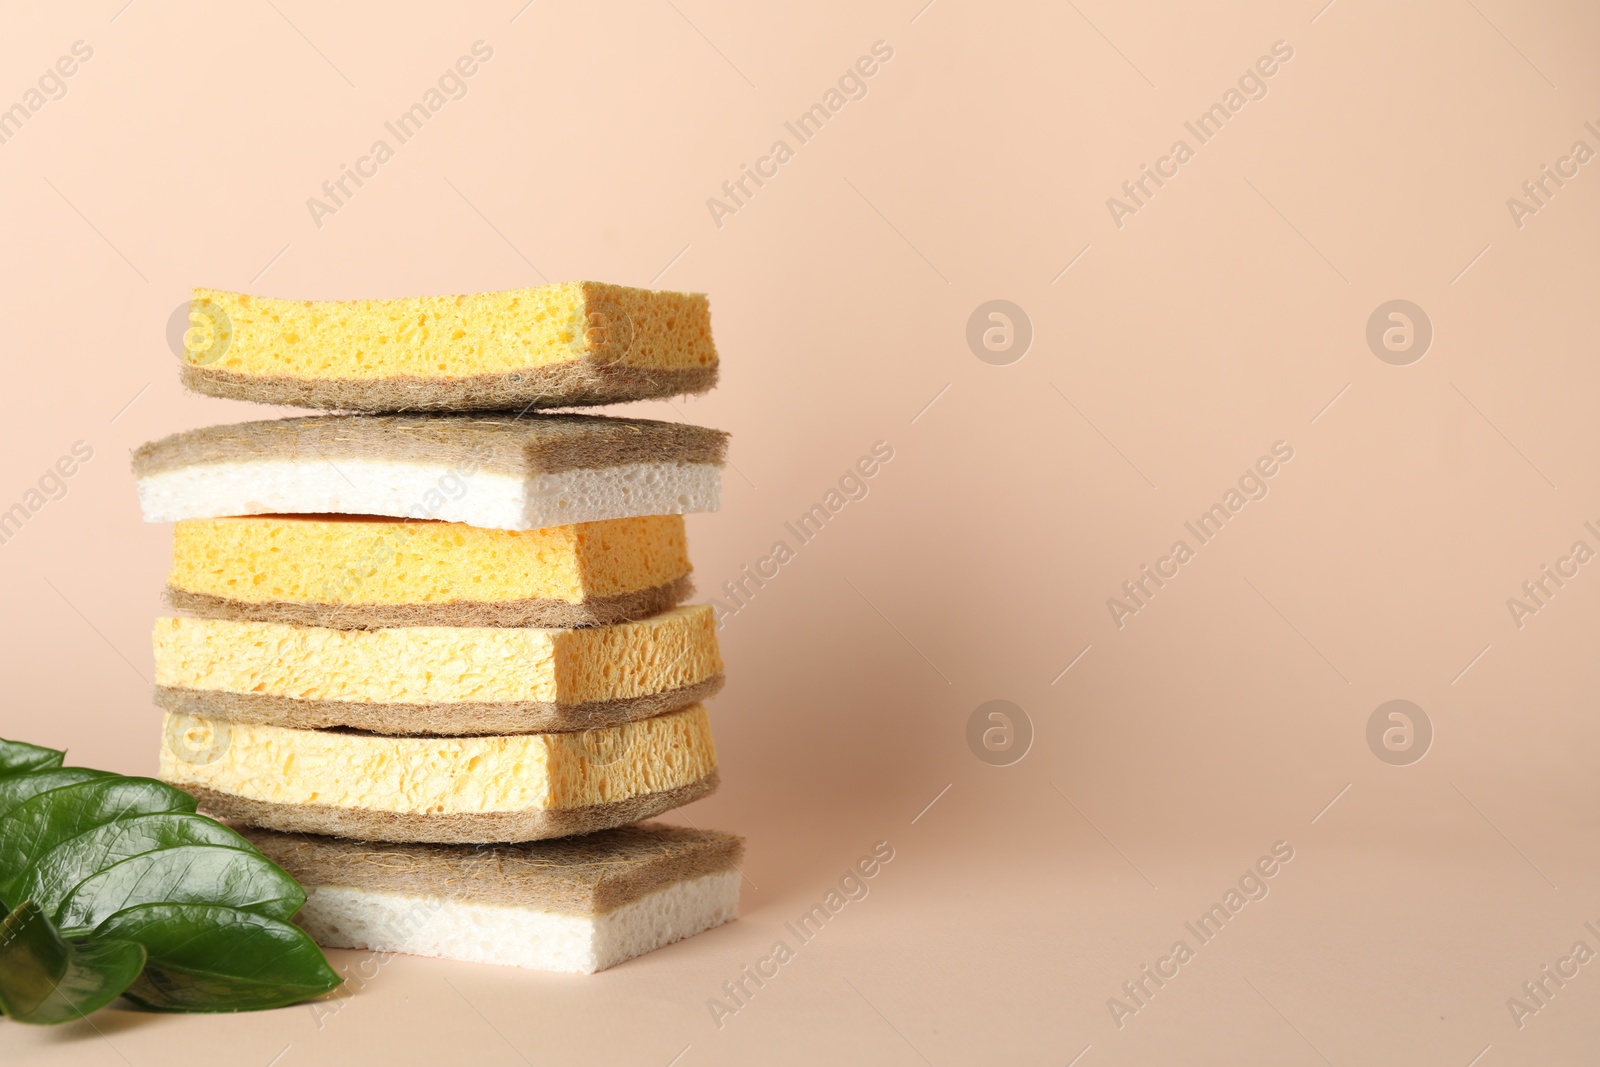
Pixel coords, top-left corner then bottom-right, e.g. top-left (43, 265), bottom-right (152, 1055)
top-left (0, 902), bottom-right (144, 1025)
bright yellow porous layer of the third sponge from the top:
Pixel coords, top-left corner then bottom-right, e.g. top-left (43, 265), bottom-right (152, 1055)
top-left (166, 515), bottom-right (690, 605)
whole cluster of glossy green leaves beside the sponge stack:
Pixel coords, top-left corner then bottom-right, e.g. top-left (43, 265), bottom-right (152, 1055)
top-left (0, 739), bottom-right (341, 1024)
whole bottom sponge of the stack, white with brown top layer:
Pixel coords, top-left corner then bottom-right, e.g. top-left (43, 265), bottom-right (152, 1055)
top-left (240, 822), bottom-right (744, 974)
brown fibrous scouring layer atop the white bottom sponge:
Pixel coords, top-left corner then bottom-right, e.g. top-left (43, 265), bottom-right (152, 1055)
top-left (240, 822), bottom-right (744, 915)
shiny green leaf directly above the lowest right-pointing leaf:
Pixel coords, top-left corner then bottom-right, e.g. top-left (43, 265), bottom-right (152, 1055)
top-left (56, 845), bottom-right (306, 931)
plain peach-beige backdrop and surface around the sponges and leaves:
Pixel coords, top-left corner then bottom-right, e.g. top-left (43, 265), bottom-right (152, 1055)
top-left (0, 0), bottom-right (1600, 1067)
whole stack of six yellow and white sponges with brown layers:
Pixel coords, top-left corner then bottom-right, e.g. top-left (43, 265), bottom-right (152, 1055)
top-left (134, 282), bottom-right (742, 973)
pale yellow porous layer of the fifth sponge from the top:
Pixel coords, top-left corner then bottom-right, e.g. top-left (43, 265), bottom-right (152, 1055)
top-left (160, 704), bottom-right (717, 816)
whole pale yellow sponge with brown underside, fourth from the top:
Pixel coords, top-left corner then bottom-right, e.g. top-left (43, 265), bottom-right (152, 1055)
top-left (154, 605), bottom-right (723, 734)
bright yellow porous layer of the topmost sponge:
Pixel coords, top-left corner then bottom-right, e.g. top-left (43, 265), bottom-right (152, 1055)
top-left (184, 282), bottom-right (717, 381)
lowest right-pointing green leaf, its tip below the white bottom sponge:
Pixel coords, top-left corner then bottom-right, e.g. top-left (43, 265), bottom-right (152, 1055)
top-left (94, 904), bottom-right (344, 1011)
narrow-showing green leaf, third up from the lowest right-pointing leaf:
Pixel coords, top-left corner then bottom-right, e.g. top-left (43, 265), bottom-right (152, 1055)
top-left (14, 813), bottom-right (256, 915)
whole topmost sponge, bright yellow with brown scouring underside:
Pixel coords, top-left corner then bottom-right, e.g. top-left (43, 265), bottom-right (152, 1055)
top-left (182, 282), bottom-right (717, 413)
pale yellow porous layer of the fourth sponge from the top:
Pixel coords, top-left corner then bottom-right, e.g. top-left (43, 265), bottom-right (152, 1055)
top-left (154, 605), bottom-right (723, 704)
